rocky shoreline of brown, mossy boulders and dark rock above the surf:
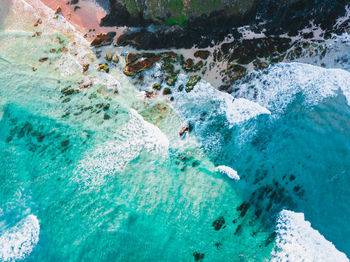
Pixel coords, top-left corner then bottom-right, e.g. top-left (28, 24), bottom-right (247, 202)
top-left (33, 0), bottom-right (350, 104)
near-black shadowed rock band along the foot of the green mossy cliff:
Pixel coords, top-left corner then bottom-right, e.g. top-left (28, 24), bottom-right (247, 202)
top-left (101, 0), bottom-right (349, 50)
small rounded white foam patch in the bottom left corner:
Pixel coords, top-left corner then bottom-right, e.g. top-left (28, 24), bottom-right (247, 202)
top-left (0, 215), bottom-right (40, 261)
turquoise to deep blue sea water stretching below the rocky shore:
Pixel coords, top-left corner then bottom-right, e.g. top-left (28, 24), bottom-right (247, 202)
top-left (0, 13), bottom-right (350, 261)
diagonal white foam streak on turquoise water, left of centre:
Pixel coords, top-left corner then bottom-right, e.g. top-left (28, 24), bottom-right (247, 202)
top-left (74, 109), bottom-right (169, 186)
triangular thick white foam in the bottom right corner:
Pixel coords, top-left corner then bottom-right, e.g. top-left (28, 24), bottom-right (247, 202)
top-left (271, 210), bottom-right (349, 262)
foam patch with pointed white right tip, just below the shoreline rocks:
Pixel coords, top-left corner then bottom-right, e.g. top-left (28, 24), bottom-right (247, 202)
top-left (173, 75), bottom-right (270, 127)
